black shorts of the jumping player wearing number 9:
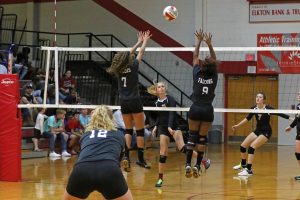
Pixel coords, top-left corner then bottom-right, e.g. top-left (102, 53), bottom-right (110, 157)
top-left (188, 103), bottom-right (214, 122)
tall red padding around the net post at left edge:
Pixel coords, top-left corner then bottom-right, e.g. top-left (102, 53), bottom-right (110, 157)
top-left (0, 74), bottom-right (22, 181)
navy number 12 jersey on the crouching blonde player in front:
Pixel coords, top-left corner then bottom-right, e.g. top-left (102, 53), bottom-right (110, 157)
top-left (77, 130), bottom-right (125, 164)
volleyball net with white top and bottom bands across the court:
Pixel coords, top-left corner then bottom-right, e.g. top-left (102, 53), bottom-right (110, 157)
top-left (19, 47), bottom-right (300, 114)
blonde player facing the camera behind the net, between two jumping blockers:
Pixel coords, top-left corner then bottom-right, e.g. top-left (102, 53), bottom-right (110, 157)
top-left (148, 82), bottom-right (210, 187)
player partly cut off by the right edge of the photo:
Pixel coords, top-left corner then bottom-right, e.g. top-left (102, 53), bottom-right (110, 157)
top-left (285, 91), bottom-right (300, 181)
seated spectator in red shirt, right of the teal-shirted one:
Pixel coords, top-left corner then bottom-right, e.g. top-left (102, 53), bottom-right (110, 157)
top-left (66, 111), bottom-right (83, 155)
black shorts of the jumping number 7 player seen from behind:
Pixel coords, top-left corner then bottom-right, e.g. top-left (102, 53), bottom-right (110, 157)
top-left (121, 98), bottom-right (143, 114)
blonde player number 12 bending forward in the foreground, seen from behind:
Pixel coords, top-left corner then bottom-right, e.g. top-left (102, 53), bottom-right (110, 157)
top-left (63, 106), bottom-right (133, 200)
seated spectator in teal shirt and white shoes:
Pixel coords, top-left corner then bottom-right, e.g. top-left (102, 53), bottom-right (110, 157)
top-left (43, 109), bottom-right (71, 157)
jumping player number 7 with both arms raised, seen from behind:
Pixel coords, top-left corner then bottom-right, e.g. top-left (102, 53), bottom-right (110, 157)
top-left (107, 31), bottom-right (152, 171)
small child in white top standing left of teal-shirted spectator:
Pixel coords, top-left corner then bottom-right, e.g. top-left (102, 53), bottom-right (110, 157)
top-left (32, 108), bottom-right (47, 151)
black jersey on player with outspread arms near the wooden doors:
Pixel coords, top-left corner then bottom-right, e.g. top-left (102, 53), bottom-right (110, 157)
top-left (246, 105), bottom-right (290, 131)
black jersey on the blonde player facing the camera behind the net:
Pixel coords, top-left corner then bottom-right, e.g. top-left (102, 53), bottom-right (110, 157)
top-left (155, 95), bottom-right (177, 128)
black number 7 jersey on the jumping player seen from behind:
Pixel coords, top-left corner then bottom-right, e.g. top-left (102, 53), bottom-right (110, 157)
top-left (118, 59), bottom-right (140, 100)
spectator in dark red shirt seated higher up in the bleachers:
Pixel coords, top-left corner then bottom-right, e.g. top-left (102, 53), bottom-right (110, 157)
top-left (59, 70), bottom-right (75, 100)
